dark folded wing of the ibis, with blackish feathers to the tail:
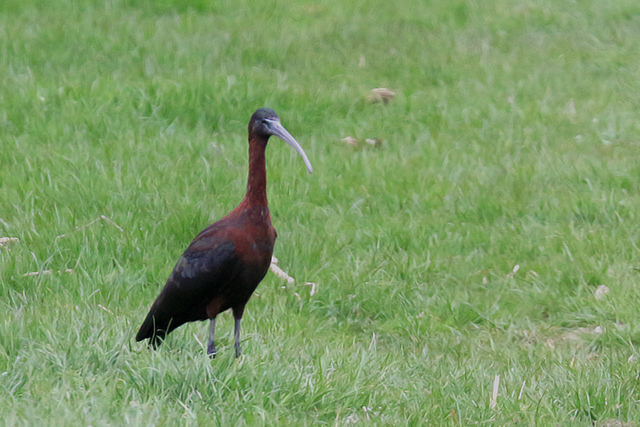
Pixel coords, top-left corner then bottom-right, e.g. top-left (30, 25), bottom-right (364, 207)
top-left (136, 235), bottom-right (238, 341)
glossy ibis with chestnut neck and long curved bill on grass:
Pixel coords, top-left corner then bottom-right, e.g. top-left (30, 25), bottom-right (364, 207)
top-left (136, 108), bottom-right (313, 358)
